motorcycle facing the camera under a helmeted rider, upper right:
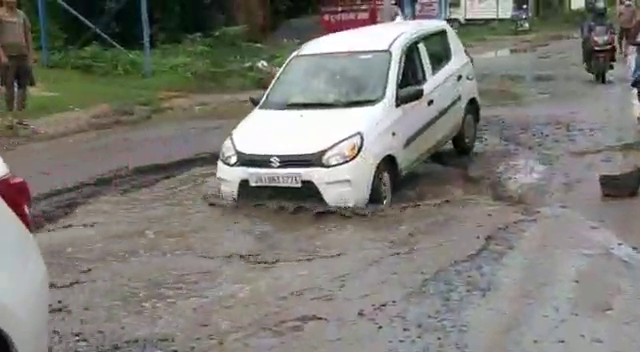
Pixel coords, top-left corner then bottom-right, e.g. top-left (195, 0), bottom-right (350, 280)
top-left (588, 26), bottom-right (616, 84)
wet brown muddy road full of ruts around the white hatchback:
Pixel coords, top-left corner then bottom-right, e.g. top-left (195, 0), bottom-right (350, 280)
top-left (25, 36), bottom-right (640, 352)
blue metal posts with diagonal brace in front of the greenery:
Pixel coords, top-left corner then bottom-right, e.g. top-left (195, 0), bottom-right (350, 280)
top-left (38, 0), bottom-right (152, 77)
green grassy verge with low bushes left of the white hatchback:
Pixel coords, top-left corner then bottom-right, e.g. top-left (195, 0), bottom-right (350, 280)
top-left (20, 28), bottom-right (294, 118)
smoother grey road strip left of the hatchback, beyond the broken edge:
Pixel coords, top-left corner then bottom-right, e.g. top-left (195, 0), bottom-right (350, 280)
top-left (3, 119), bottom-right (234, 194)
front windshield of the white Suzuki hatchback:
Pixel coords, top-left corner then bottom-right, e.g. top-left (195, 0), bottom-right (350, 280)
top-left (260, 51), bottom-right (391, 110)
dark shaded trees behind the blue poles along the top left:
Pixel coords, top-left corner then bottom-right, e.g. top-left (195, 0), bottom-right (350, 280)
top-left (22, 0), bottom-right (318, 48)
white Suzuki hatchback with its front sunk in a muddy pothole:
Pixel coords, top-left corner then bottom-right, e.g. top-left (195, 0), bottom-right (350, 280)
top-left (217, 20), bottom-right (480, 207)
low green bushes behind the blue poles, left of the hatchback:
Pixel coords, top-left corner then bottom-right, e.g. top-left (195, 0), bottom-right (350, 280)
top-left (49, 27), bottom-right (293, 88)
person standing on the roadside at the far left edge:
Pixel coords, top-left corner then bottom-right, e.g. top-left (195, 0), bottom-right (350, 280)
top-left (0, 0), bottom-right (35, 112)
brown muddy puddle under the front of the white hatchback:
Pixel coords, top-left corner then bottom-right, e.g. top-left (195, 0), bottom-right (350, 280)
top-left (204, 150), bottom-right (505, 218)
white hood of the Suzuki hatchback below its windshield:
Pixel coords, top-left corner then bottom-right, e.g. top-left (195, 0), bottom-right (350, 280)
top-left (232, 107), bottom-right (377, 155)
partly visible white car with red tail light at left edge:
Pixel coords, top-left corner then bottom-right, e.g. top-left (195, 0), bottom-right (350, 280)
top-left (0, 158), bottom-right (49, 352)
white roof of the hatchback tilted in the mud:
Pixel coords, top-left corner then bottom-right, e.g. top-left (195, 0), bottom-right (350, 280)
top-left (297, 20), bottom-right (447, 55)
